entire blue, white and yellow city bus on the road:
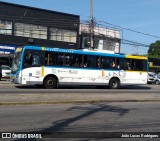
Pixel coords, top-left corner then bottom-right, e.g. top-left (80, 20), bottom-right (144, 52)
top-left (11, 46), bottom-right (148, 89)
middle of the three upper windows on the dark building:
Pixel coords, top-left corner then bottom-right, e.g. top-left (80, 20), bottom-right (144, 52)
top-left (14, 23), bottom-right (47, 39)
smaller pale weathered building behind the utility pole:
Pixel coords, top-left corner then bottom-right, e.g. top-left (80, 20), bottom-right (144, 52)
top-left (80, 24), bottom-right (121, 53)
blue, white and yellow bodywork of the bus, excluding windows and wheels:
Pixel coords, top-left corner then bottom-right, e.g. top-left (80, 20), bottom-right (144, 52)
top-left (12, 46), bottom-right (147, 86)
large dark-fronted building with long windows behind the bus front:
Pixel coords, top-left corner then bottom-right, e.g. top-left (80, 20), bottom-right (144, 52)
top-left (0, 2), bottom-right (80, 65)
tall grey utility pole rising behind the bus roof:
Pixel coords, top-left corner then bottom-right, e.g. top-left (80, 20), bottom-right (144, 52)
top-left (89, 0), bottom-right (94, 49)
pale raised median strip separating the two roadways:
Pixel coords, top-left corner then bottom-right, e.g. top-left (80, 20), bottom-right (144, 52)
top-left (0, 81), bottom-right (160, 105)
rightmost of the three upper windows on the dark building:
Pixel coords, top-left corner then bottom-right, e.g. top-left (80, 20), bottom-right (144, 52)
top-left (49, 28), bottom-right (77, 43)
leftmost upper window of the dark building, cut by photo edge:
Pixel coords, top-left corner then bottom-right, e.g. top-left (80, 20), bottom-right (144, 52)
top-left (0, 20), bottom-right (12, 35)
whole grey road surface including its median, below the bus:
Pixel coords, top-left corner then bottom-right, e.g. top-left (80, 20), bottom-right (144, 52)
top-left (0, 80), bottom-right (160, 141)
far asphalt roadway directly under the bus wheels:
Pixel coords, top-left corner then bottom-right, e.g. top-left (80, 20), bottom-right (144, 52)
top-left (0, 79), bottom-right (160, 93)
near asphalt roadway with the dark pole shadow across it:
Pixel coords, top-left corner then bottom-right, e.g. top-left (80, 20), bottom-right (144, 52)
top-left (0, 102), bottom-right (160, 139)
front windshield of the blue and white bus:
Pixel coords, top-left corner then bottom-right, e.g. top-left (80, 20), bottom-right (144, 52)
top-left (11, 51), bottom-right (22, 73)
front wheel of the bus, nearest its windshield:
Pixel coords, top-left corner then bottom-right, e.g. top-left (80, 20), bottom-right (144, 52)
top-left (43, 76), bottom-right (57, 89)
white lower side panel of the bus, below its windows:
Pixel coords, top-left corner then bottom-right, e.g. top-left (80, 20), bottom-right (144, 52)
top-left (14, 67), bottom-right (147, 85)
